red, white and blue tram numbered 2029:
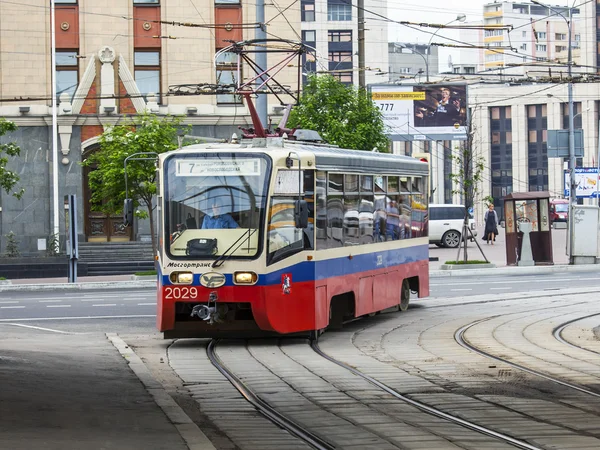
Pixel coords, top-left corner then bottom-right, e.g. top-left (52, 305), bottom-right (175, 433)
top-left (150, 130), bottom-right (429, 338)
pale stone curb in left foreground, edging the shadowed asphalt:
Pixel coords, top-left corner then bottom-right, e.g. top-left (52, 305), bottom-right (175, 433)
top-left (106, 333), bottom-right (216, 450)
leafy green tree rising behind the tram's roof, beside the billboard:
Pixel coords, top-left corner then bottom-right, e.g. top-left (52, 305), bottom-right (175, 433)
top-left (288, 75), bottom-right (388, 152)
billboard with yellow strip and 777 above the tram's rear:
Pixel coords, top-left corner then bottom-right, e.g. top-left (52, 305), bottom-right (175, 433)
top-left (371, 84), bottom-right (467, 141)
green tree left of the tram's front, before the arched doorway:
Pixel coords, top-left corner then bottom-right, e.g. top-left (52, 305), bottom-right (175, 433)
top-left (83, 114), bottom-right (187, 252)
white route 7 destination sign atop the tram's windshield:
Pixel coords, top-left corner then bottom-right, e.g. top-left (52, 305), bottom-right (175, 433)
top-left (176, 158), bottom-right (260, 177)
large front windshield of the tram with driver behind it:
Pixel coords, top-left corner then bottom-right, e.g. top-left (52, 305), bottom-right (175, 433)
top-left (164, 153), bottom-right (271, 260)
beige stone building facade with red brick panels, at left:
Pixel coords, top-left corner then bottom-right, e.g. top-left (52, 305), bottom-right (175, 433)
top-left (0, 0), bottom-right (300, 256)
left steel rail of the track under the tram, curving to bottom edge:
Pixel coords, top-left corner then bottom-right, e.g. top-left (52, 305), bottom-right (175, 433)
top-left (206, 339), bottom-right (335, 450)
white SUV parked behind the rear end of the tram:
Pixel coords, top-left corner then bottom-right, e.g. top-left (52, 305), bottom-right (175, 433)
top-left (429, 204), bottom-right (477, 248)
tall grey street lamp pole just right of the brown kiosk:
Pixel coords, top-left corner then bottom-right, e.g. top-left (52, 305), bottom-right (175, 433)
top-left (531, 0), bottom-right (577, 264)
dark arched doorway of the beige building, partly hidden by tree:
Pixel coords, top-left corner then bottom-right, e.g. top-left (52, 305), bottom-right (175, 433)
top-left (83, 143), bottom-right (133, 242)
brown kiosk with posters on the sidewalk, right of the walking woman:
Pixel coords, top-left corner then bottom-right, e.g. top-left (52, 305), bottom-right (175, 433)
top-left (503, 191), bottom-right (554, 266)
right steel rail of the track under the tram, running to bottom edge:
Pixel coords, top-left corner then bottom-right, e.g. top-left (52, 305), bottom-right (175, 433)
top-left (310, 341), bottom-right (542, 450)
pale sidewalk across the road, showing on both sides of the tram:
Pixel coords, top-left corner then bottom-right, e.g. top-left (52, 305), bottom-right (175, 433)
top-left (0, 228), bottom-right (600, 292)
